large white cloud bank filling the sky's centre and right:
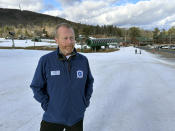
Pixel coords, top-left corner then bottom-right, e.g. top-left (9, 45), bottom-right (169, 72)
top-left (43, 0), bottom-right (175, 28)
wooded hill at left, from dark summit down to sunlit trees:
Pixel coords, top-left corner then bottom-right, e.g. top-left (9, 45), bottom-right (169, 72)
top-left (0, 8), bottom-right (88, 37)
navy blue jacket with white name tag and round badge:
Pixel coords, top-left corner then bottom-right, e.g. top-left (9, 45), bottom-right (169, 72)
top-left (30, 49), bottom-right (94, 126)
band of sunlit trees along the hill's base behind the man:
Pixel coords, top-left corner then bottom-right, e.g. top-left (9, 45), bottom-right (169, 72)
top-left (0, 23), bottom-right (175, 44)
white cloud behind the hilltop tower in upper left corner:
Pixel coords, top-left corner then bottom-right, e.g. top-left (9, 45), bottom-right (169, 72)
top-left (0, 0), bottom-right (44, 11)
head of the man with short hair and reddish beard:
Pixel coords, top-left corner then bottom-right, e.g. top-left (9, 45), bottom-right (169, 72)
top-left (55, 23), bottom-right (75, 56)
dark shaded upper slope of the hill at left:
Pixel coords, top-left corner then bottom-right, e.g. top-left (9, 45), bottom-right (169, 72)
top-left (0, 8), bottom-right (73, 26)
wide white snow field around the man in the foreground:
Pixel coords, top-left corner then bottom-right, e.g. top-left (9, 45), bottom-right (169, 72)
top-left (0, 47), bottom-right (175, 131)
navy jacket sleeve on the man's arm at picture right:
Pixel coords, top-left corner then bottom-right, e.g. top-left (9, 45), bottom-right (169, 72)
top-left (85, 60), bottom-right (94, 107)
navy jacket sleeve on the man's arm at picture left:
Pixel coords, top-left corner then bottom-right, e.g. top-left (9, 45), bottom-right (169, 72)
top-left (30, 57), bottom-right (49, 111)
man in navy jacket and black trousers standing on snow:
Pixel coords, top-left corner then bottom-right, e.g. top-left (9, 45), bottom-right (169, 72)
top-left (30, 23), bottom-right (94, 131)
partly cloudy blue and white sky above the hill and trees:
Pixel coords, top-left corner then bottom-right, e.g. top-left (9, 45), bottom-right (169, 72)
top-left (0, 0), bottom-right (175, 29)
